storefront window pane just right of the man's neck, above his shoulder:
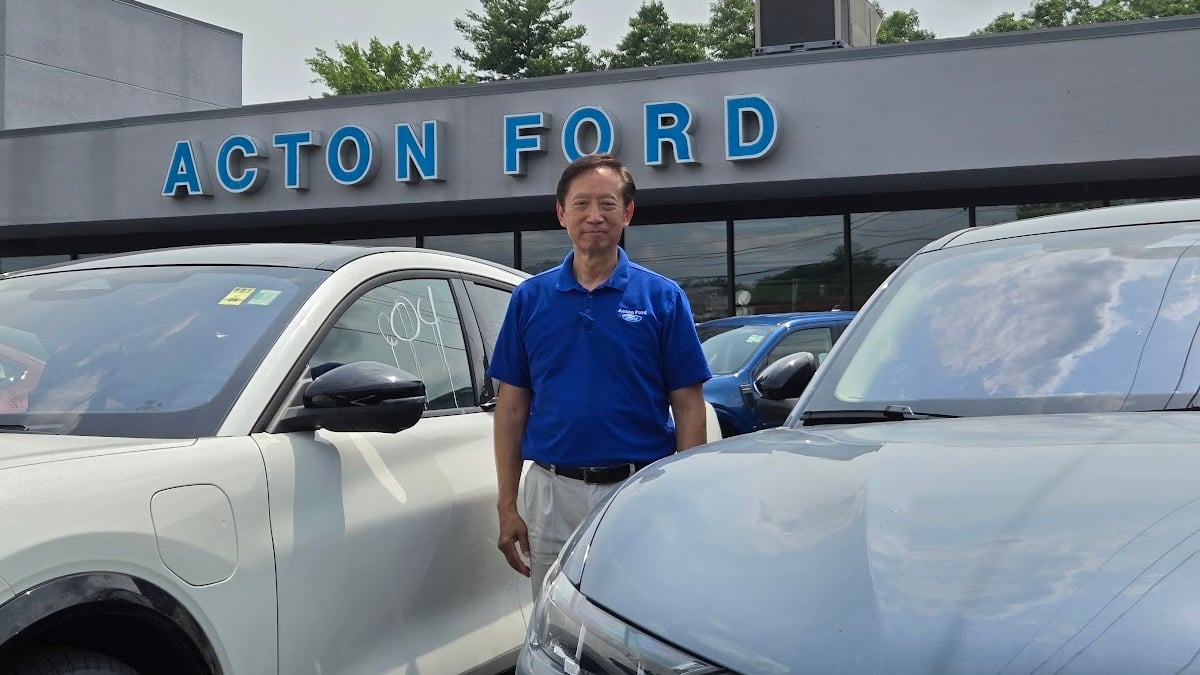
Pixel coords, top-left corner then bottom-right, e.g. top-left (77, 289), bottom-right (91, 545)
top-left (625, 221), bottom-right (730, 322)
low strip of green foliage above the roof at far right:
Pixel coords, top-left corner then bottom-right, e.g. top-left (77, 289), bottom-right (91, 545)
top-left (972, 0), bottom-right (1200, 35)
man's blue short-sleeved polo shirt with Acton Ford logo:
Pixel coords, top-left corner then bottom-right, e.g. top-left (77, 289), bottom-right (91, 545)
top-left (487, 249), bottom-right (712, 467)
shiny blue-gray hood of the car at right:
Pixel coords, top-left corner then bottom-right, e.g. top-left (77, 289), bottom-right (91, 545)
top-left (580, 412), bottom-right (1200, 674)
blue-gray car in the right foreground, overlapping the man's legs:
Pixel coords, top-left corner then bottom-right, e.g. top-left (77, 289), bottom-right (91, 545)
top-left (518, 201), bottom-right (1200, 675)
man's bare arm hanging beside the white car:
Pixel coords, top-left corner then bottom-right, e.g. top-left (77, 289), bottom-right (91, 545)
top-left (492, 382), bottom-right (532, 577)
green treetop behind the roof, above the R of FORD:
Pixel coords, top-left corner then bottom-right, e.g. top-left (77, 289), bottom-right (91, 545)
top-left (600, 0), bottom-right (706, 68)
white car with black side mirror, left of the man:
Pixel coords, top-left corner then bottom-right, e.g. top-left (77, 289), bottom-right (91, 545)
top-left (0, 244), bottom-right (529, 675)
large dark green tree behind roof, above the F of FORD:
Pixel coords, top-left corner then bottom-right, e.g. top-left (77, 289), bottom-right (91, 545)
top-left (454, 0), bottom-right (596, 79)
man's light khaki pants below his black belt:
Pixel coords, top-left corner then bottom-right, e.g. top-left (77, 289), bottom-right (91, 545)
top-left (522, 464), bottom-right (620, 601)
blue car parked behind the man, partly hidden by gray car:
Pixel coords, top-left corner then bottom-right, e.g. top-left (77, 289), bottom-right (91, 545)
top-left (696, 311), bottom-right (854, 437)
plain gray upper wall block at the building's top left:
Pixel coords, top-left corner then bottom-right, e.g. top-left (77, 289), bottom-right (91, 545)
top-left (0, 0), bottom-right (241, 130)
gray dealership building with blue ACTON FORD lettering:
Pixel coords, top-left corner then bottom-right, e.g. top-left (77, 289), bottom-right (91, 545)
top-left (0, 0), bottom-right (1200, 319)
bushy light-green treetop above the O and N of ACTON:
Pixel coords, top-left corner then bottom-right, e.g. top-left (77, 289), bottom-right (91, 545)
top-left (304, 37), bottom-right (475, 96)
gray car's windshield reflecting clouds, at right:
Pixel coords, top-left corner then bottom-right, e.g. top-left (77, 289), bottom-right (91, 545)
top-left (793, 225), bottom-right (1200, 419)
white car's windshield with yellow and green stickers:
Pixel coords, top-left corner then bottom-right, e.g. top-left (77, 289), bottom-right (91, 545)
top-left (0, 265), bottom-right (328, 438)
